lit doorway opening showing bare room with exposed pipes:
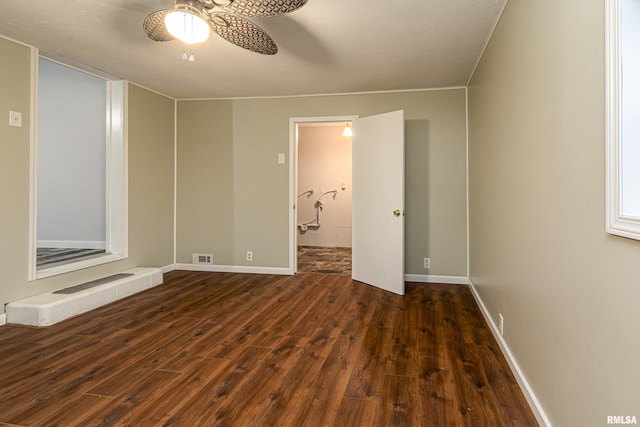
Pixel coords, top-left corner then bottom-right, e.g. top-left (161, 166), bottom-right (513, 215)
top-left (292, 118), bottom-right (352, 276)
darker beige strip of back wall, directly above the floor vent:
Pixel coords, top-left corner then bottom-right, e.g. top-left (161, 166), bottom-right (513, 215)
top-left (176, 101), bottom-right (235, 265)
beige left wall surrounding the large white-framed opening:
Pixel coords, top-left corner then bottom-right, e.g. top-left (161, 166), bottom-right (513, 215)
top-left (0, 38), bottom-right (173, 312)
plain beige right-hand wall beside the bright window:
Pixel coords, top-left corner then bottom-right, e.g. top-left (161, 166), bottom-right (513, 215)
top-left (469, 0), bottom-right (640, 426)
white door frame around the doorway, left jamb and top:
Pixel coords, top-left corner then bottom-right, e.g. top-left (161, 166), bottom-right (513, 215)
top-left (288, 115), bottom-right (360, 274)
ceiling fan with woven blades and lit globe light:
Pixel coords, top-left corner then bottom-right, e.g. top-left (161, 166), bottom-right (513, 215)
top-left (142, 0), bottom-right (308, 55)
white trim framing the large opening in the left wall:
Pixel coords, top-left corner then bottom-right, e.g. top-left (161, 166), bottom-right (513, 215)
top-left (27, 48), bottom-right (129, 281)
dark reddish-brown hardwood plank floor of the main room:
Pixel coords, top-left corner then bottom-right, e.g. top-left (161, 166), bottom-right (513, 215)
top-left (0, 271), bottom-right (537, 427)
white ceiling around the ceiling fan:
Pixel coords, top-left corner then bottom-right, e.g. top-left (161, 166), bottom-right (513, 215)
top-left (0, 0), bottom-right (507, 99)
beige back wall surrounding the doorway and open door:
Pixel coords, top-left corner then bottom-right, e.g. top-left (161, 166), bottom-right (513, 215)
top-left (177, 89), bottom-right (467, 276)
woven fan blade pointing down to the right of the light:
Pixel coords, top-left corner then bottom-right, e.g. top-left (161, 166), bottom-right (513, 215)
top-left (211, 13), bottom-right (278, 55)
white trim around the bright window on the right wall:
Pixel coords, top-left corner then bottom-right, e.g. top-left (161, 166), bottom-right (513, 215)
top-left (606, 0), bottom-right (640, 240)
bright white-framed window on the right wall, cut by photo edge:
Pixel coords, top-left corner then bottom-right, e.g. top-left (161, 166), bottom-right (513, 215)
top-left (607, 0), bottom-right (640, 240)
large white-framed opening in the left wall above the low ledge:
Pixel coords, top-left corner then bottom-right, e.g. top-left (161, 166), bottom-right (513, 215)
top-left (29, 54), bottom-right (127, 280)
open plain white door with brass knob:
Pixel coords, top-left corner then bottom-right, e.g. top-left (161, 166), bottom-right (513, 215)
top-left (352, 110), bottom-right (404, 295)
